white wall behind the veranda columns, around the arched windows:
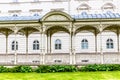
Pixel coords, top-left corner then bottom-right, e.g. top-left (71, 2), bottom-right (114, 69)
top-left (0, 32), bottom-right (118, 53)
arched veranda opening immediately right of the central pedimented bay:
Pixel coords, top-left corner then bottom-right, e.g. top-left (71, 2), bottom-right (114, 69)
top-left (75, 25), bottom-right (99, 53)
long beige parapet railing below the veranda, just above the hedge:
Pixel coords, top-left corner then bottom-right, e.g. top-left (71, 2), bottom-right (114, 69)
top-left (0, 52), bottom-right (120, 66)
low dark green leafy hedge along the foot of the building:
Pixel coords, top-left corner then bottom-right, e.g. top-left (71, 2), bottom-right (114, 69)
top-left (0, 64), bottom-right (120, 73)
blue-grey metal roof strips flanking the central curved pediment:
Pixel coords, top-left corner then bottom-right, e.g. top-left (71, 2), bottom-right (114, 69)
top-left (0, 11), bottom-right (120, 21)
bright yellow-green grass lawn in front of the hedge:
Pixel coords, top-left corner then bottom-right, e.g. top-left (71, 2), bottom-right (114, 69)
top-left (0, 71), bottom-right (120, 80)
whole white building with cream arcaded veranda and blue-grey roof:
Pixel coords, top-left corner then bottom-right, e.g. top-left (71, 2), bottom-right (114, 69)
top-left (0, 0), bottom-right (120, 65)
